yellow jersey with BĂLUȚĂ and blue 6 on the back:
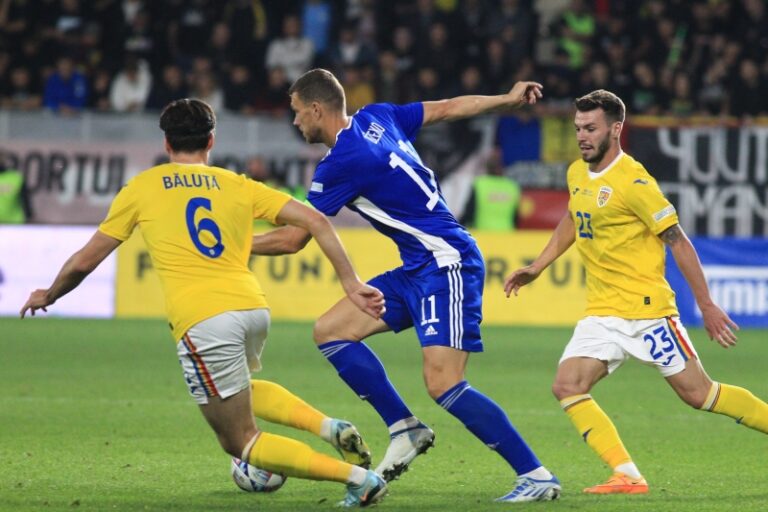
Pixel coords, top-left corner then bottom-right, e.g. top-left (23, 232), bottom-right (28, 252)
top-left (99, 163), bottom-right (291, 340)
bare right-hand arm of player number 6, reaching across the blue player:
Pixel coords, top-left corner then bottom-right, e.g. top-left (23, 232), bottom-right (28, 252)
top-left (277, 199), bottom-right (384, 319)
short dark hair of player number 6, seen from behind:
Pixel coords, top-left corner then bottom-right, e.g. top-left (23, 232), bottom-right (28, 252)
top-left (160, 98), bottom-right (216, 153)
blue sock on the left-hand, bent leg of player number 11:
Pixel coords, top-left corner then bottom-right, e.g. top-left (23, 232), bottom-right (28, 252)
top-left (317, 340), bottom-right (413, 426)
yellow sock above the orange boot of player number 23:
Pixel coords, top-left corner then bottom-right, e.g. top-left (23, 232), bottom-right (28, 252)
top-left (560, 395), bottom-right (632, 469)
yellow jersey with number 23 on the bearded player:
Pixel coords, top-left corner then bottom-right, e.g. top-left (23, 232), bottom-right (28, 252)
top-left (568, 152), bottom-right (678, 319)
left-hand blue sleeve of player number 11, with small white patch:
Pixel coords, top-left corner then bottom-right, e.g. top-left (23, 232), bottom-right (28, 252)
top-left (307, 157), bottom-right (360, 216)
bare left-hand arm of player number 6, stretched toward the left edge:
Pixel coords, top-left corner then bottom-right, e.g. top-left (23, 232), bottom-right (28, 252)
top-left (19, 231), bottom-right (122, 318)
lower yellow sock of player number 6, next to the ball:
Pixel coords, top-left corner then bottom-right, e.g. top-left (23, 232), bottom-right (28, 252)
top-left (248, 432), bottom-right (354, 483)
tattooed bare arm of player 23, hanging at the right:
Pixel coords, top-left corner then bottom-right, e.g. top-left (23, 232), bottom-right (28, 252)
top-left (659, 224), bottom-right (739, 348)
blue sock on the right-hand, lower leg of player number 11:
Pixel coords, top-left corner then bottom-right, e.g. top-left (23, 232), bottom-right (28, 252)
top-left (435, 380), bottom-right (541, 475)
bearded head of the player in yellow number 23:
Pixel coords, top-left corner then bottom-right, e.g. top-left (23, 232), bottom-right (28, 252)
top-left (574, 89), bottom-right (626, 163)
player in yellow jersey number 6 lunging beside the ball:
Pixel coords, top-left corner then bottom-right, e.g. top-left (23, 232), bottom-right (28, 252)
top-left (21, 99), bottom-right (386, 506)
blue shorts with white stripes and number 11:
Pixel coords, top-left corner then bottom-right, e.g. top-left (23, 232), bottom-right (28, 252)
top-left (369, 258), bottom-right (485, 352)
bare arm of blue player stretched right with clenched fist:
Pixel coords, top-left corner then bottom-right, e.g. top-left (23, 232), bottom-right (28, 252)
top-left (422, 82), bottom-right (543, 125)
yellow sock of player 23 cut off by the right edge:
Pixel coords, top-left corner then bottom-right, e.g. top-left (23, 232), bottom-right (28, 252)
top-left (701, 382), bottom-right (768, 434)
